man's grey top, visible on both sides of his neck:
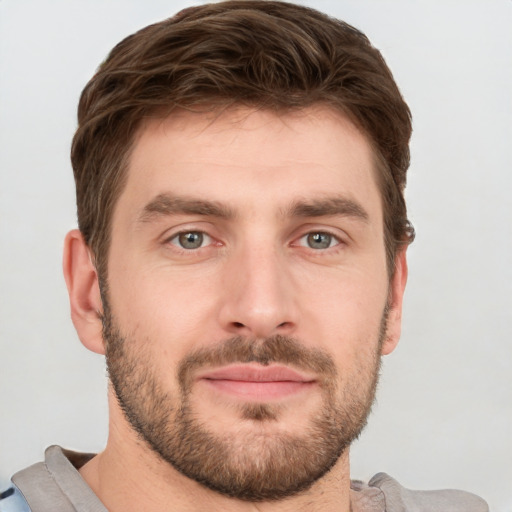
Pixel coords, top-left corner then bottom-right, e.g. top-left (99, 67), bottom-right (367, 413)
top-left (0, 446), bottom-right (489, 512)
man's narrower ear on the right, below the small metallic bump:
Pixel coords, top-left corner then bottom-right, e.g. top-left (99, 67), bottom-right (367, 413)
top-left (381, 247), bottom-right (407, 355)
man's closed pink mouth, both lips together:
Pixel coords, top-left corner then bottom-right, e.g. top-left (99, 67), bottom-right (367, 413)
top-left (197, 364), bottom-right (316, 402)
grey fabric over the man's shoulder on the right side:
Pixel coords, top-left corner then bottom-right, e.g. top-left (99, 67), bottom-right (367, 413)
top-left (353, 473), bottom-right (489, 512)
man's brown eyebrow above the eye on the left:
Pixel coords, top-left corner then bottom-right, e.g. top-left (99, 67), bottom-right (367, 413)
top-left (138, 194), bottom-right (235, 222)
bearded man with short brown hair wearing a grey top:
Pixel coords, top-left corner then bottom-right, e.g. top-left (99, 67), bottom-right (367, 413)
top-left (0, 0), bottom-right (487, 512)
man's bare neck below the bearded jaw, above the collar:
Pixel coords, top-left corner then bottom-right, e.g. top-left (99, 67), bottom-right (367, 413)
top-left (80, 396), bottom-right (350, 512)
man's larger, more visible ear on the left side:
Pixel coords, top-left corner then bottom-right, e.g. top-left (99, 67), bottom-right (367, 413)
top-left (63, 229), bottom-right (105, 354)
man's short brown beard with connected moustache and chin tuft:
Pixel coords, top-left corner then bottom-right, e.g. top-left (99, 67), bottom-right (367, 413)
top-left (103, 300), bottom-right (387, 502)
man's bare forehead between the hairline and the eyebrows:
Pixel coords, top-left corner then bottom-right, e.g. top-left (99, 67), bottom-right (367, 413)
top-left (120, 106), bottom-right (380, 221)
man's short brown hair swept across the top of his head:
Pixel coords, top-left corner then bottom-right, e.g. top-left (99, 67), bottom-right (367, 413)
top-left (71, 0), bottom-right (414, 276)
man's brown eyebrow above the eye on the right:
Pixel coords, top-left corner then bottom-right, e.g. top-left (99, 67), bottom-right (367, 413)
top-left (286, 196), bottom-right (369, 222)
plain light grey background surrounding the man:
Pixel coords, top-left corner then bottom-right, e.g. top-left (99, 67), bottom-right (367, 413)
top-left (0, 0), bottom-right (512, 512)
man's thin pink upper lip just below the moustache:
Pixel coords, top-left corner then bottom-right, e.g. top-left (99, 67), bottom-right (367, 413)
top-left (198, 364), bottom-right (316, 382)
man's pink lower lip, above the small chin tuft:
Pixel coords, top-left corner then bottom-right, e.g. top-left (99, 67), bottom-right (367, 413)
top-left (202, 379), bottom-right (313, 401)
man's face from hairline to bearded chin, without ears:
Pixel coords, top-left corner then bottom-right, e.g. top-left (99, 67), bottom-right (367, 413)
top-left (104, 108), bottom-right (402, 501)
